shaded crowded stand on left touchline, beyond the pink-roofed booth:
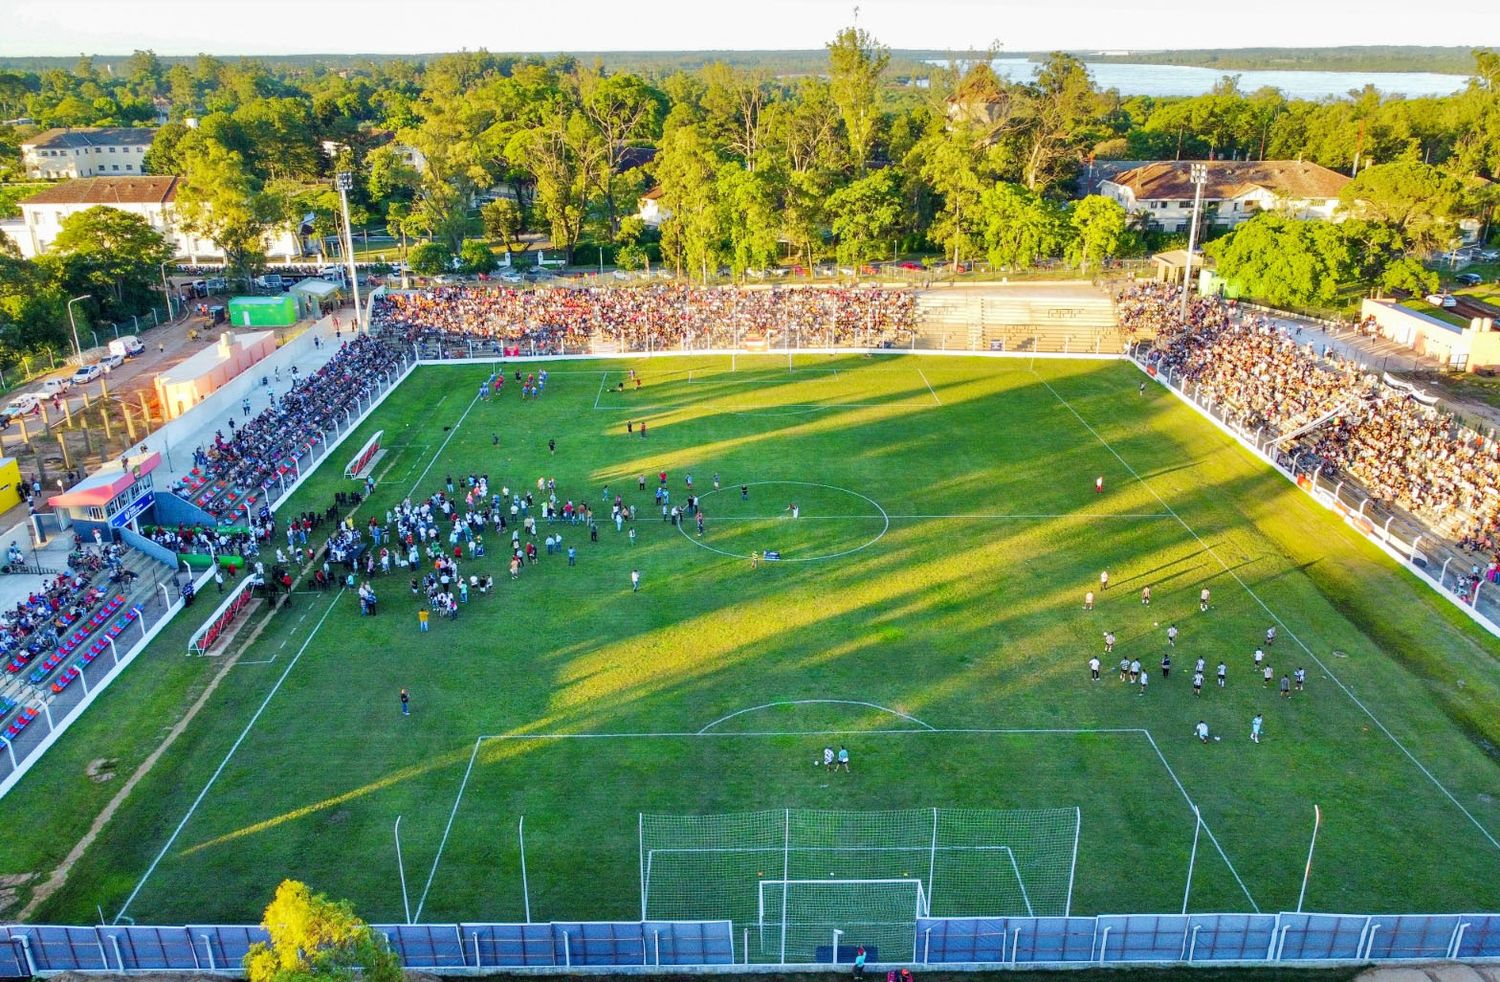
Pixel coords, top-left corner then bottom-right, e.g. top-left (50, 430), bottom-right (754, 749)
top-left (171, 334), bottom-right (399, 521)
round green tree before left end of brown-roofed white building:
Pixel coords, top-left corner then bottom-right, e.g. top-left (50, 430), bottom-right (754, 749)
top-left (47, 205), bottom-right (173, 321)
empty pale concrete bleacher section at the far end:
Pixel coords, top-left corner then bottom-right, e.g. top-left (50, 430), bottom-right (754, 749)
top-left (917, 283), bottom-right (1125, 354)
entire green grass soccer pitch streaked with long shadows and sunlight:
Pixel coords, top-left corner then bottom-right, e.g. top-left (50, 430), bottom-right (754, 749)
top-left (0, 355), bottom-right (1500, 924)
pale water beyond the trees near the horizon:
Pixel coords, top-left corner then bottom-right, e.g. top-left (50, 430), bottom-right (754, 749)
top-left (933, 58), bottom-right (1469, 99)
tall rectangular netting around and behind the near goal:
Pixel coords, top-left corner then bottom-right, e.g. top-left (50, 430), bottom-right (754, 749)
top-left (641, 808), bottom-right (1080, 961)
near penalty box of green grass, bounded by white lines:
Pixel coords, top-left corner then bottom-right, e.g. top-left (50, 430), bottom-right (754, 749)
top-left (422, 725), bottom-right (1259, 924)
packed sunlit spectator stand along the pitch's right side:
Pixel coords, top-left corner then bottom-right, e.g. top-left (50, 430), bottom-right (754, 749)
top-left (1119, 283), bottom-right (1500, 569)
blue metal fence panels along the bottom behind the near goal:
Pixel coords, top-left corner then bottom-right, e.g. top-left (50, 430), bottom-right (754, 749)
top-left (0, 913), bottom-right (1500, 978)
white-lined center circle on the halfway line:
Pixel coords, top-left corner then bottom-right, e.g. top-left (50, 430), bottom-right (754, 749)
top-left (678, 481), bottom-right (891, 562)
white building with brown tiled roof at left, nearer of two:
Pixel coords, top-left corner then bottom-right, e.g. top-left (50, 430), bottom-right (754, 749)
top-left (0, 177), bottom-right (303, 262)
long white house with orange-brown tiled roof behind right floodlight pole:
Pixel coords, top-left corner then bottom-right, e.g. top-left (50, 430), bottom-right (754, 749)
top-left (1098, 160), bottom-right (1349, 232)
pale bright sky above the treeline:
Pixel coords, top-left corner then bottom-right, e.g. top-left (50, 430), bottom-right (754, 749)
top-left (0, 0), bottom-right (1500, 57)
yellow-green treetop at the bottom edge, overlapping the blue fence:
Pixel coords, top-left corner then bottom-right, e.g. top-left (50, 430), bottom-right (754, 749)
top-left (245, 880), bottom-right (405, 982)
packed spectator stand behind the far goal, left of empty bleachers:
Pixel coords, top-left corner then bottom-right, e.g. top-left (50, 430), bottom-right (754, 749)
top-left (372, 285), bottom-right (917, 357)
